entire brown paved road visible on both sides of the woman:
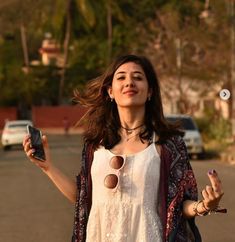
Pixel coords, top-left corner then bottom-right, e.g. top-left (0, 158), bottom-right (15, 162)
top-left (0, 135), bottom-right (235, 242)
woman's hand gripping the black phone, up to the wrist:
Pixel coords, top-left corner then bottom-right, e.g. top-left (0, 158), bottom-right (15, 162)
top-left (23, 135), bottom-right (51, 172)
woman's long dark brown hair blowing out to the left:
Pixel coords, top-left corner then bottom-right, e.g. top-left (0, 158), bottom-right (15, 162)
top-left (74, 55), bottom-right (183, 149)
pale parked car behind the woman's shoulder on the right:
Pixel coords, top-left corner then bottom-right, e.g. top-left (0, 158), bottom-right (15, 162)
top-left (166, 114), bottom-right (204, 158)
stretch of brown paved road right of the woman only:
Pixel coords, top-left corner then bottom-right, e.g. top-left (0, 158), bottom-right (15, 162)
top-left (191, 160), bottom-right (235, 242)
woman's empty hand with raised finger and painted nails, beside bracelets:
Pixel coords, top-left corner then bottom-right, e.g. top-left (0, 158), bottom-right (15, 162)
top-left (202, 170), bottom-right (224, 210)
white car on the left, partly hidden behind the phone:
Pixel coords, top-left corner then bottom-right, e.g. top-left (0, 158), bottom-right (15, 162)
top-left (1, 120), bottom-right (33, 150)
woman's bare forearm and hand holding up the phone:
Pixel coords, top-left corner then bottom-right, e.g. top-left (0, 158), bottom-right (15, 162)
top-left (23, 135), bottom-right (77, 203)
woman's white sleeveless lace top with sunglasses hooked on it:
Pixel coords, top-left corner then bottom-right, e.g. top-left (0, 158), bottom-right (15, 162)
top-left (86, 140), bottom-right (162, 242)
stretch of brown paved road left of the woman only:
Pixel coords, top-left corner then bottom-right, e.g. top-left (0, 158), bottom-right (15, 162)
top-left (0, 135), bottom-right (80, 242)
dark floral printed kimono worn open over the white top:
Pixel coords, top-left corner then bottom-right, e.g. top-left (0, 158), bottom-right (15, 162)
top-left (72, 136), bottom-right (202, 242)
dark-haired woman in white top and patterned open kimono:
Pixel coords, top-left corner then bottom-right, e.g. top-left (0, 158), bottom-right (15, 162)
top-left (23, 55), bottom-right (226, 242)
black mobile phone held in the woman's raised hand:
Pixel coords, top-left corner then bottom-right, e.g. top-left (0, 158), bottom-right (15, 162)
top-left (27, 125), bottom-right (46, 161)
